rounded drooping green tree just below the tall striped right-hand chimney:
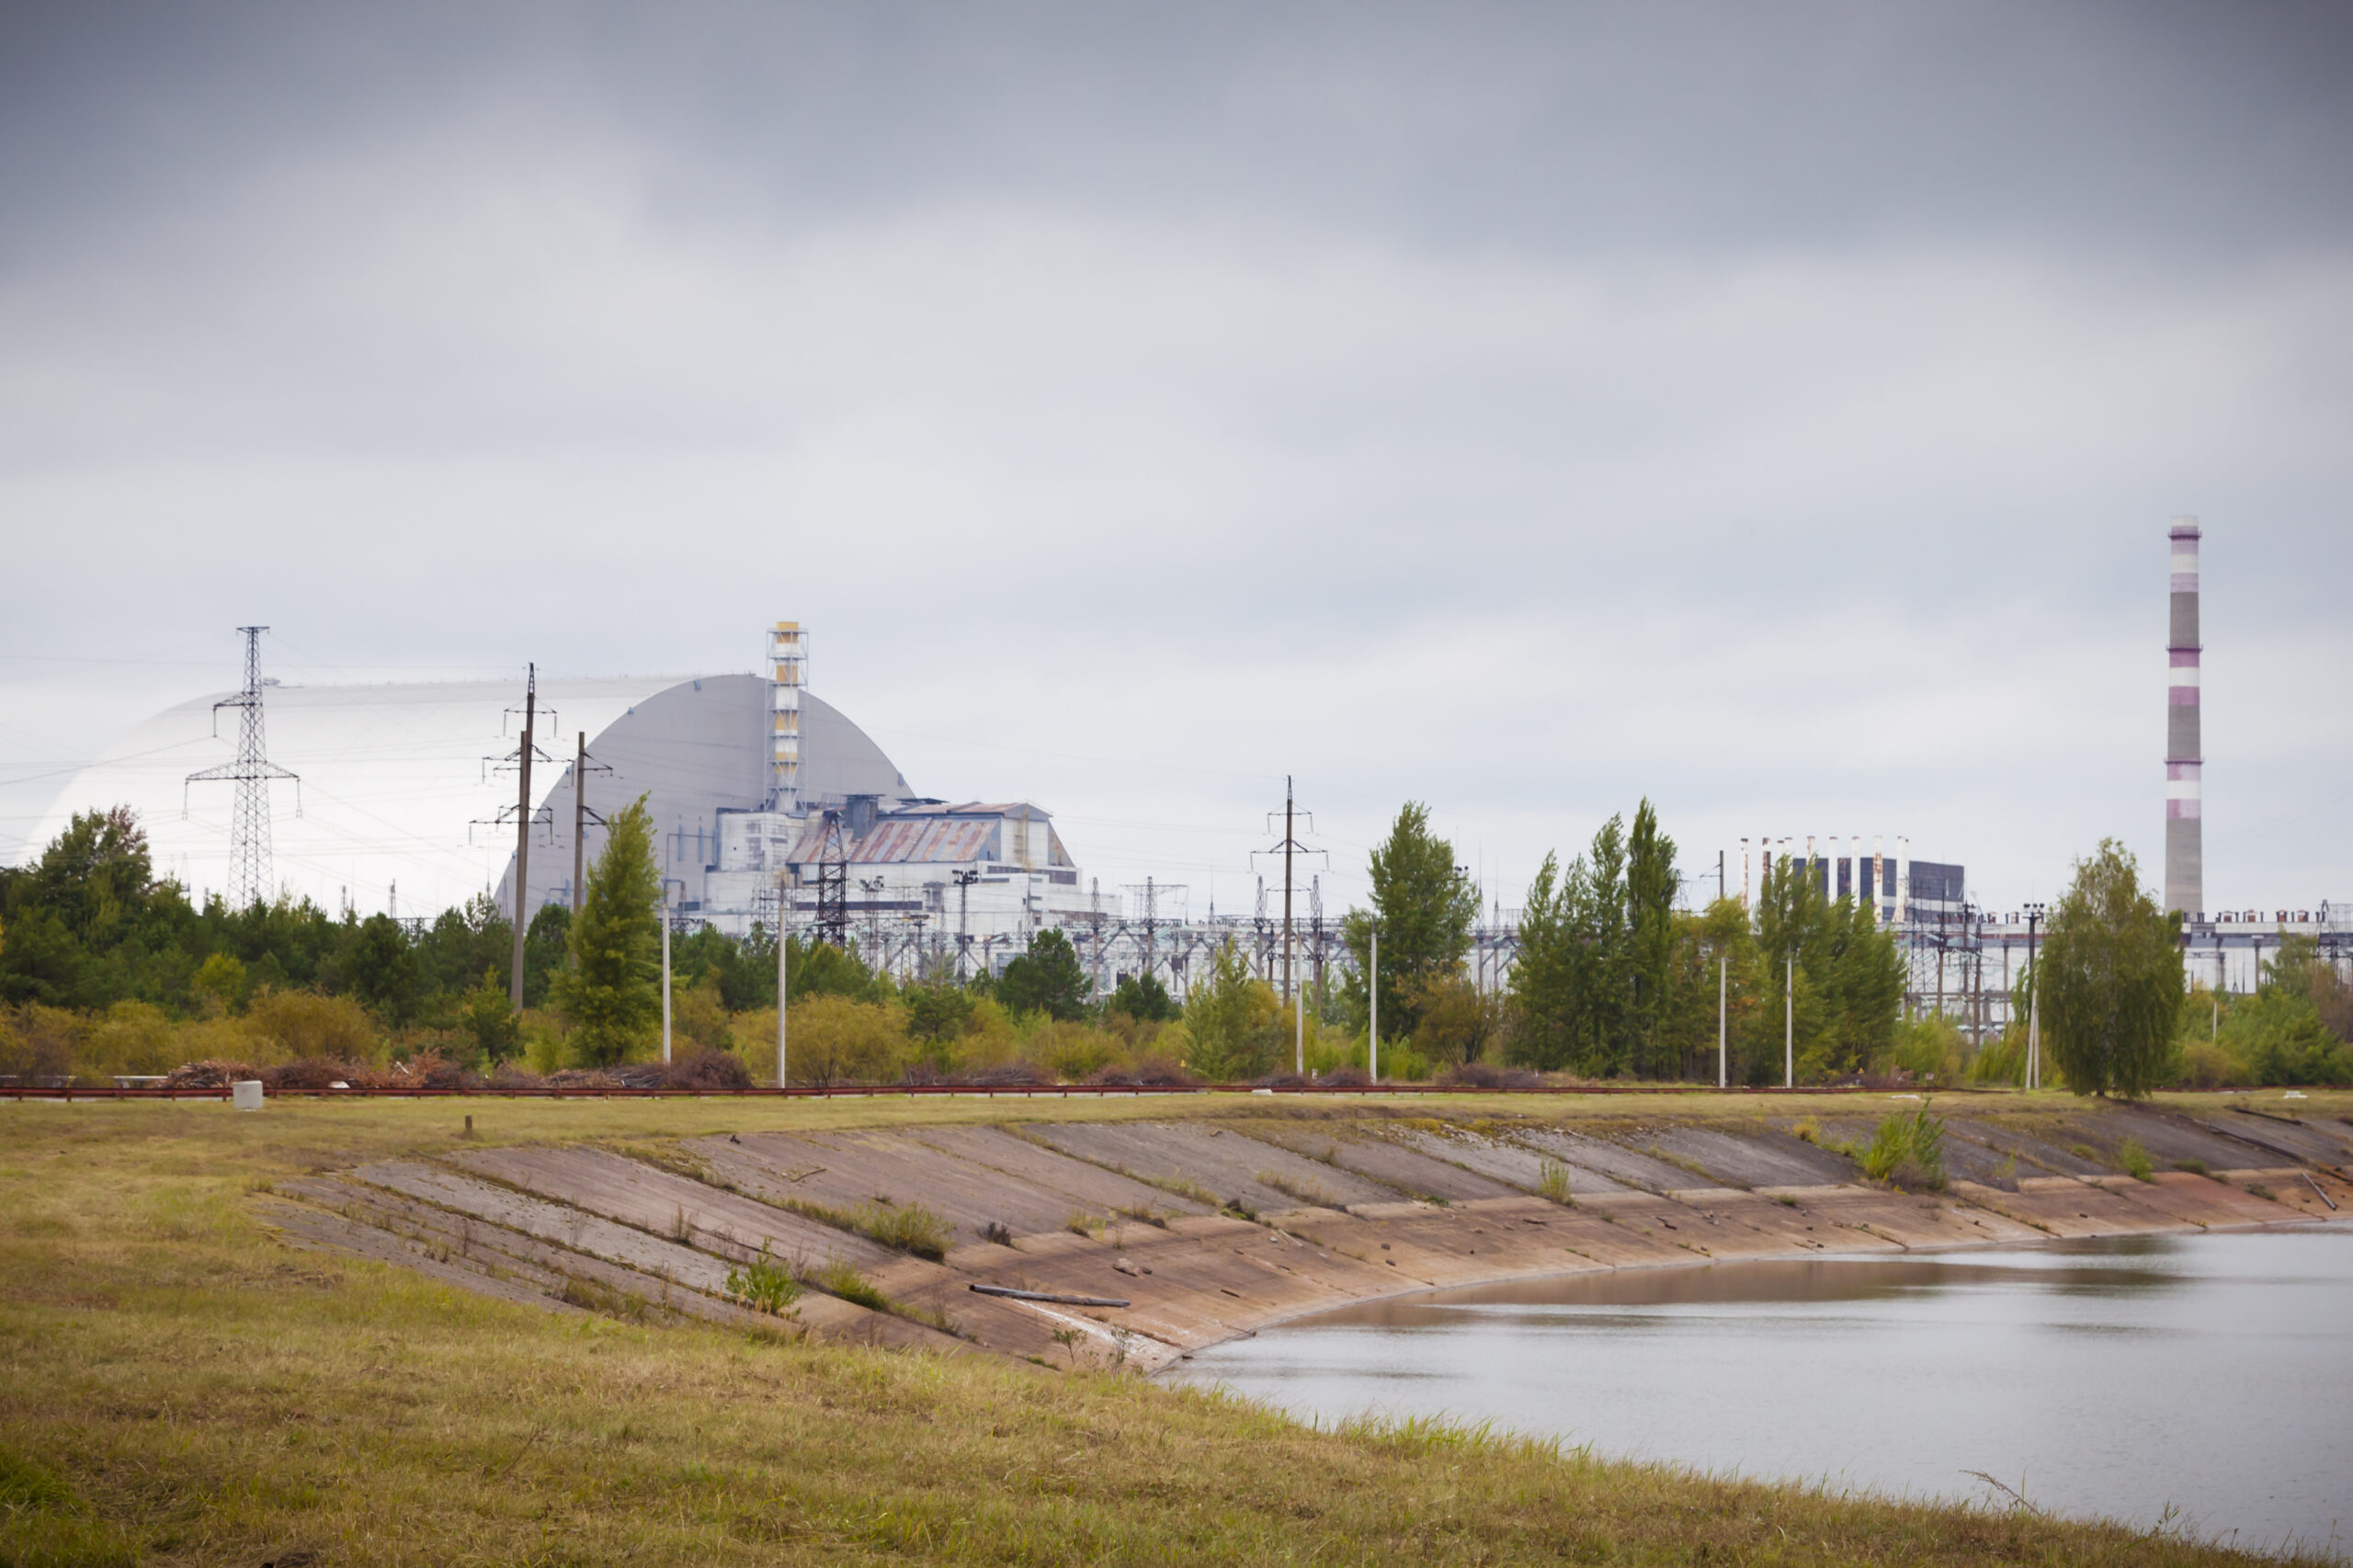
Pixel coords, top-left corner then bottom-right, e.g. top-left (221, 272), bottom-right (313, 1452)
top-left (2042, 838), bottom-right (2184, 1097)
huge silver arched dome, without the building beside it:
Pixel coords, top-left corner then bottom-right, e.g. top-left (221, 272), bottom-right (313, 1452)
top-left (35, 674), bottom-right (913, 915)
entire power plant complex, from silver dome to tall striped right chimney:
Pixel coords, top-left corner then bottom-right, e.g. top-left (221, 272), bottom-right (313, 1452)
top-left (35, 516), bottom-right (2353, 1007)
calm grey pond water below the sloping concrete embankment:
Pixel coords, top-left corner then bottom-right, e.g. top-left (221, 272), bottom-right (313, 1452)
top-left (1188, 1227), bottom-right (2353, 1551)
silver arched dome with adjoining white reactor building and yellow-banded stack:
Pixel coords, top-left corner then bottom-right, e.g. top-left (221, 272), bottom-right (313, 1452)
top-left (38, 621), bottom-right (1118, 960)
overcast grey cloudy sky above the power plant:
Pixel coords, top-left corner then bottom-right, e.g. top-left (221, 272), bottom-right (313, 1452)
top-left (0, 3), bottom-right (2353, 911)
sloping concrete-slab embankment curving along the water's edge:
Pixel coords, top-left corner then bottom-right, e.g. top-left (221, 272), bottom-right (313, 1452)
top-left (229, 1087), bottom-right (2353, 1375)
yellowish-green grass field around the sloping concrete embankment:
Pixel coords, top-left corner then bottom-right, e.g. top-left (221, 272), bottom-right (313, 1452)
top-left (0, 1097), bottom-right (2334, 1563)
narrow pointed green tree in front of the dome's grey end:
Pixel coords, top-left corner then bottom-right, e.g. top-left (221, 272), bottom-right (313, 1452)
top-left (551, 796), bottom-right (661, 1066)
